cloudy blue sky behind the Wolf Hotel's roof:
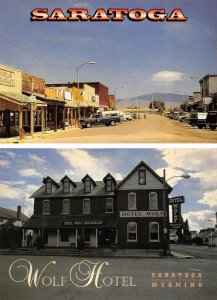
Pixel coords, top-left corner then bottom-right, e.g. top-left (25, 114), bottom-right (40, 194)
top-left (0, 148), bottom-right (217, 230)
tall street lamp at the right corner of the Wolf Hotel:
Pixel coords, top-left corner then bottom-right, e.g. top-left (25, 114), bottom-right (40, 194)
top-left (163, 169), bottom-right (191, 256)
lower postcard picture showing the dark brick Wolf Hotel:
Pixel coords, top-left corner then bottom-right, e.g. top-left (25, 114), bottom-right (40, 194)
top-left (0, 148), bottom-right (217, 300)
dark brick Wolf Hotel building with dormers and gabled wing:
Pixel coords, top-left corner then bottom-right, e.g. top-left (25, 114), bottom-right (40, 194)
top-left (23, 162), bottom-right (172, 249)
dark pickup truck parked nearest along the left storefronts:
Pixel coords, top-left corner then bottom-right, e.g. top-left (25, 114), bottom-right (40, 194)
top-left (80, 112), bottom-right (123, 128)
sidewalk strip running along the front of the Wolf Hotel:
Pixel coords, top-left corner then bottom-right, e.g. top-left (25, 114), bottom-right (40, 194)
top-left (0, 248), bottom-right (193, 259)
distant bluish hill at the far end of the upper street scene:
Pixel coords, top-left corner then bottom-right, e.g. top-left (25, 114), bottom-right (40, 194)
top-left (117, 93), bottom-right (188, 108)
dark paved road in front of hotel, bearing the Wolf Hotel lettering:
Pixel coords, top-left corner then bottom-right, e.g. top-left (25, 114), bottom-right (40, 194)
top-left (0, 256), bottom-right (217, 300)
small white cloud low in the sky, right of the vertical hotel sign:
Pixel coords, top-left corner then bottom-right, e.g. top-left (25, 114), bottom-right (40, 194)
top-left (182, 210), bottom-right (214, 231)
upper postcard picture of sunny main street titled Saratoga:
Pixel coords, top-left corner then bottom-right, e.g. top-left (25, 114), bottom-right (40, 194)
top-left (0, 0), bottom-right (217, 144)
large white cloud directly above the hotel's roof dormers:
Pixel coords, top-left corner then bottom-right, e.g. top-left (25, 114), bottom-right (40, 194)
top-left (58, 149), bottom-right (123, 180)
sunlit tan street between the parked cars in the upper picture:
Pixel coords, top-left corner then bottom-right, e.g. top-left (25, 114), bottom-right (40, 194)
top-left (20, 115), bottom-right (217, 143)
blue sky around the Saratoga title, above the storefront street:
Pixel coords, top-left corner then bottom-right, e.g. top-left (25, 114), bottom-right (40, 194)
top-left (0, 0), bottom-right (217, 98)
